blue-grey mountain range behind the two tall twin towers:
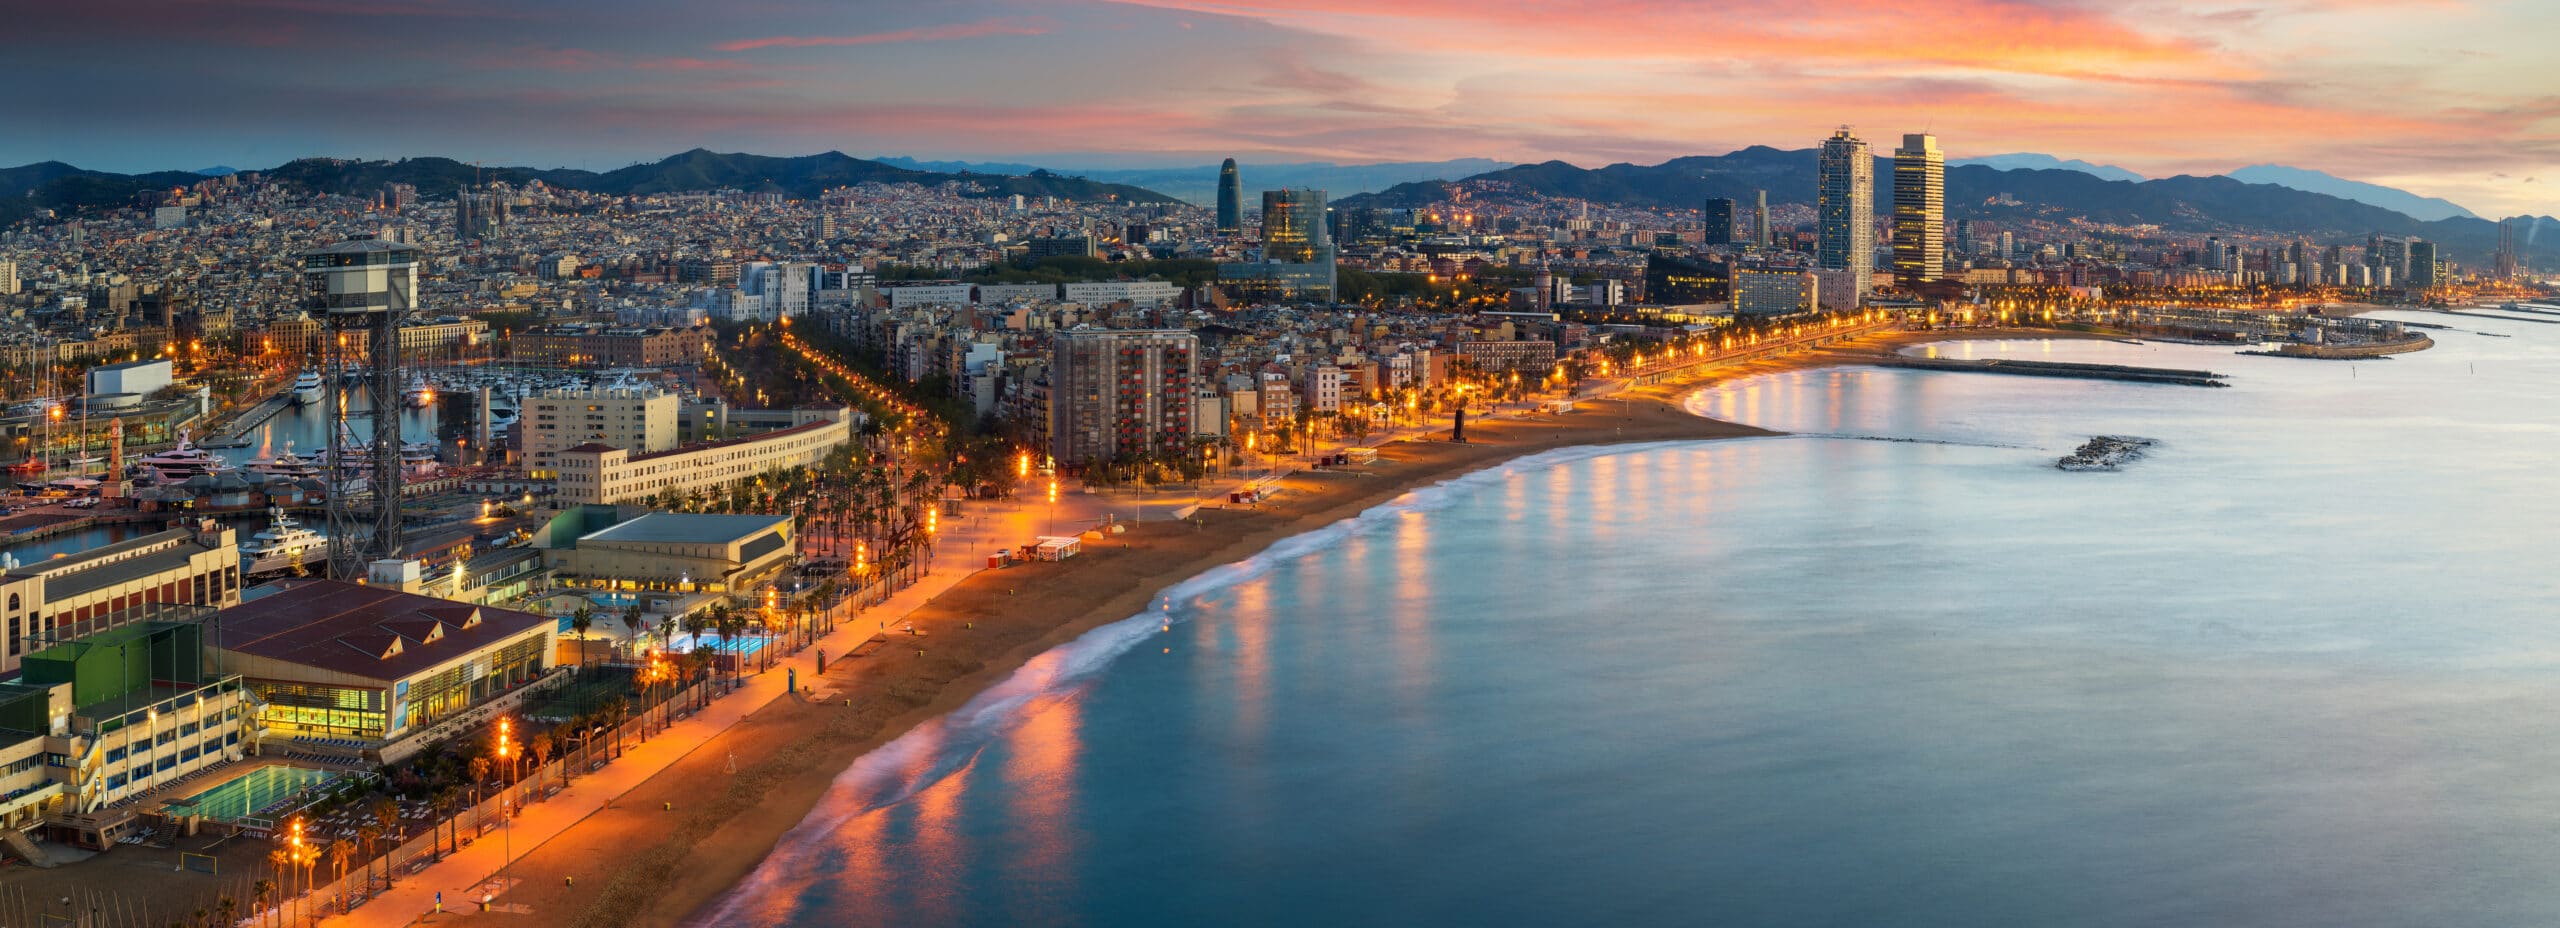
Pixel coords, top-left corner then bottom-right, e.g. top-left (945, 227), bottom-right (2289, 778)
top-left (1336, 146), bottom-right (2539, 259)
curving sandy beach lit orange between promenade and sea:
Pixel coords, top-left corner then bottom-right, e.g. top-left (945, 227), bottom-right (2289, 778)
top-left (483, 328), bottom-right (2104, 928)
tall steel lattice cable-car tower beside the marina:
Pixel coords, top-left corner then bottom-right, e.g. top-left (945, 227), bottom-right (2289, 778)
top-left (302, 238), bottom-right (417, 579)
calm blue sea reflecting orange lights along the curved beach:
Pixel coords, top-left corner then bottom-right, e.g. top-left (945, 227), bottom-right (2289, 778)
top-left (696, 315), bottom-right (2560, 925)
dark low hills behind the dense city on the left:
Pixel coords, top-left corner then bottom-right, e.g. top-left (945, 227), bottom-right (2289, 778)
top-left (0, 149), bottom-right (1175, 226)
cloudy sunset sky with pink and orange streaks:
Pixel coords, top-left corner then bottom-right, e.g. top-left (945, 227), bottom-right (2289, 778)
top-left (0, 0), bottom-right (2560, 215)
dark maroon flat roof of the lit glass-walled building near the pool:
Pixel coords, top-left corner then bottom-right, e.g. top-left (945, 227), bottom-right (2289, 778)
top-left (215, 579), bottom-right (553, 684)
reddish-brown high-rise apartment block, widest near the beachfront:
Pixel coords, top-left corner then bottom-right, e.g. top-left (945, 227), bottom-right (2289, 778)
top-left (1050, 328), bottom-right (1192, 467)
